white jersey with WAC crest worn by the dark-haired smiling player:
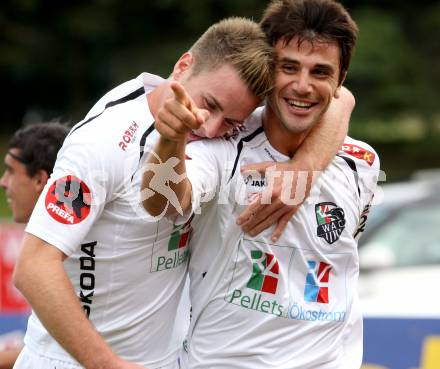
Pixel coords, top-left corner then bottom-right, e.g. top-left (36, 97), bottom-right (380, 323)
top-left (181, 110), bottom-right (379, 369)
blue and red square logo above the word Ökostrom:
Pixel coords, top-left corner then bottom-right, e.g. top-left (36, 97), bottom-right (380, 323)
top-left (304, 260), bottom-right (332, 304)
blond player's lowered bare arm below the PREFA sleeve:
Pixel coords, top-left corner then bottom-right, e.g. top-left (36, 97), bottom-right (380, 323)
top-left (14, 234), bottom-right (143, 369)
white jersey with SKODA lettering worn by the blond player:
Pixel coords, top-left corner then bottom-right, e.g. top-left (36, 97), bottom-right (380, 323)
top-left (25, 73), bottom-right (189, 368)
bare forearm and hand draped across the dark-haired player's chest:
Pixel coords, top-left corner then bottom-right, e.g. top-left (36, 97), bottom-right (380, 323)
top-left (237, 87), bottom-right (355, 241)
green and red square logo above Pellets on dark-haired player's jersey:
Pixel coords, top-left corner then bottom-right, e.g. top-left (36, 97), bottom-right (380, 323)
top-left (246, 250), bottom-right (279, 294)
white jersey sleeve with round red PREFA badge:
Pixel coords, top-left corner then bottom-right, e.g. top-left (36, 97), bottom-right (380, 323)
top-left (26, 128), bottom-right (118, 256)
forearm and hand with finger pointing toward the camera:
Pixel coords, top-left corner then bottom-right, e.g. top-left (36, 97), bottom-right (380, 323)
top-left (141, 82), bottom-right (209, 216)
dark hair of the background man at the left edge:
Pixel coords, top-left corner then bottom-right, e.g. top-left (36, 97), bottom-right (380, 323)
top-left (8, 122), bottom-right (70, 177)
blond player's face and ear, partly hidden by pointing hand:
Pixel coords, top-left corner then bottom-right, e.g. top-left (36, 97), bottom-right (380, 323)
top-left (173, 54), bottom-right (260, 140)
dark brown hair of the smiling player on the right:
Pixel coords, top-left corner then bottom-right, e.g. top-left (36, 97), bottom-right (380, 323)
top-left (260, 0), bottom-right (358, 83)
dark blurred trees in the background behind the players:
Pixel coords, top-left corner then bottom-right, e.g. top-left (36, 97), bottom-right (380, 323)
top-left (0, 0), bottom-right (440, 179)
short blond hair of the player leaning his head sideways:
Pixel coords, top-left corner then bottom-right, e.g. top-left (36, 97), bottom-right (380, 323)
top-left (190, 17), bottom-right (275, 99)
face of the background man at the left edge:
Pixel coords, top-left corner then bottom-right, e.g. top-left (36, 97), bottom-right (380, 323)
top-left (0, 148), bottom-right (45, 223)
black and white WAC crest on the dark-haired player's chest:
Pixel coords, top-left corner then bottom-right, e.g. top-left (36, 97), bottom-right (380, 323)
top-left (315, 202), bottom-right (345, 245)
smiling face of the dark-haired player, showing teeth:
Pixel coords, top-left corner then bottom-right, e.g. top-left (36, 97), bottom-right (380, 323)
top-left (268, 37), bottom-right (340, 134)
